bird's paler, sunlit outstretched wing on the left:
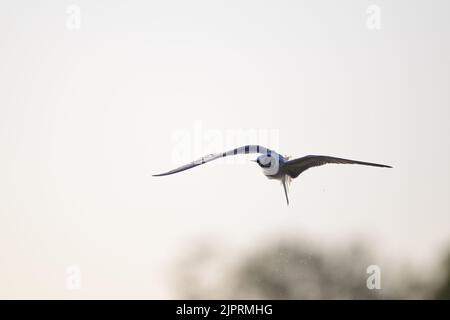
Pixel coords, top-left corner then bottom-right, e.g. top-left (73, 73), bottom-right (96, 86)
top-left (153, 145), bottom-right (278, 177)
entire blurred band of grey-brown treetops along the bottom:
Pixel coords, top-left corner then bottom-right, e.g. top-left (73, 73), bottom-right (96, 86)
top-left (175, 239), bottom-right (450, 299)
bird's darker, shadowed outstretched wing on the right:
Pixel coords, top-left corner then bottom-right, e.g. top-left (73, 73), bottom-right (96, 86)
top-left (284, 155), bottom-right (392, 178)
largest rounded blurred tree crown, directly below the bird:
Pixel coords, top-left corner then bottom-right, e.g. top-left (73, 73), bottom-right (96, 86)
top-left (227, 242), bottom-right (379, 299)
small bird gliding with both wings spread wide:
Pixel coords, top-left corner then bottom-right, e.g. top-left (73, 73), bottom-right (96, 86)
top-left (153, 145), bottom-right (392, 205)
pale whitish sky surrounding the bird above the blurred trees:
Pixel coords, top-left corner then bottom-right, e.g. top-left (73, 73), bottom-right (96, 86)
top-left (0, 0), bottom-right (450, 298)
